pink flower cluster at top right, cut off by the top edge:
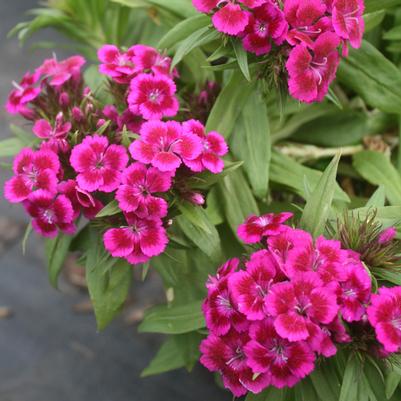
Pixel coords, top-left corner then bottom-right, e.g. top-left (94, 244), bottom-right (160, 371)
top-left (193, 0), bottom-right (364, 103)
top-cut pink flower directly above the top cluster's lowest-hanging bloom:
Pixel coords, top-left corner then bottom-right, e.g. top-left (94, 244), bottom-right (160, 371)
top-left (284, 0), bottom-right (333, 46)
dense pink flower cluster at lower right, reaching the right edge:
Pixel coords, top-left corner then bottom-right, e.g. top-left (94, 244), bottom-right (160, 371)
top-left (201, 213), bottom-right (401, 396)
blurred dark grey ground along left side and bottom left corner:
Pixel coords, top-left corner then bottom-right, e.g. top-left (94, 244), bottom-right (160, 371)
top-left (0, 0), bottom-right (230, 401)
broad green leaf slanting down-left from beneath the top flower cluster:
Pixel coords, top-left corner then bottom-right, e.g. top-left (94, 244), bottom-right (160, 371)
top-left (206, 71), bottom-right (254, 138)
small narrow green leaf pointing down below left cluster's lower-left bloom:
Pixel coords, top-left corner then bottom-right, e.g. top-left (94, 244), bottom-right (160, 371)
top-left (45, 233), bottom-right (74, 288)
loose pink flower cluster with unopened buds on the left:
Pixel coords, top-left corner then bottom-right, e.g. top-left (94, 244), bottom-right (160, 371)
top-left (5, 45), bottom-right (228, 264)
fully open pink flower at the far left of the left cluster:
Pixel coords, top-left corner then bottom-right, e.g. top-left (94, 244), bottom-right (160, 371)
top-left (4, 148), bottom-right (60, 203)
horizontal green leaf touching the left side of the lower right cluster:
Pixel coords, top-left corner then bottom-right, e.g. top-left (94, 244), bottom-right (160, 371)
top-left (138, 300), bottom-right (205, 334)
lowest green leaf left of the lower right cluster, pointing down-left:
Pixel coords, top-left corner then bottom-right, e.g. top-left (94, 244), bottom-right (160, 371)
top-left (141, 337), bottom-right (185, 377)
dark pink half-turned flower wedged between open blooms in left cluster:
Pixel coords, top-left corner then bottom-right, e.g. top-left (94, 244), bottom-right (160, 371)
top-left (58, 180), bottom-right (103, 220)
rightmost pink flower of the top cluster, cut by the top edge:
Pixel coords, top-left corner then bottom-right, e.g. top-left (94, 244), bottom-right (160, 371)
top-left (333, 0), bottom-right (365, 49)
